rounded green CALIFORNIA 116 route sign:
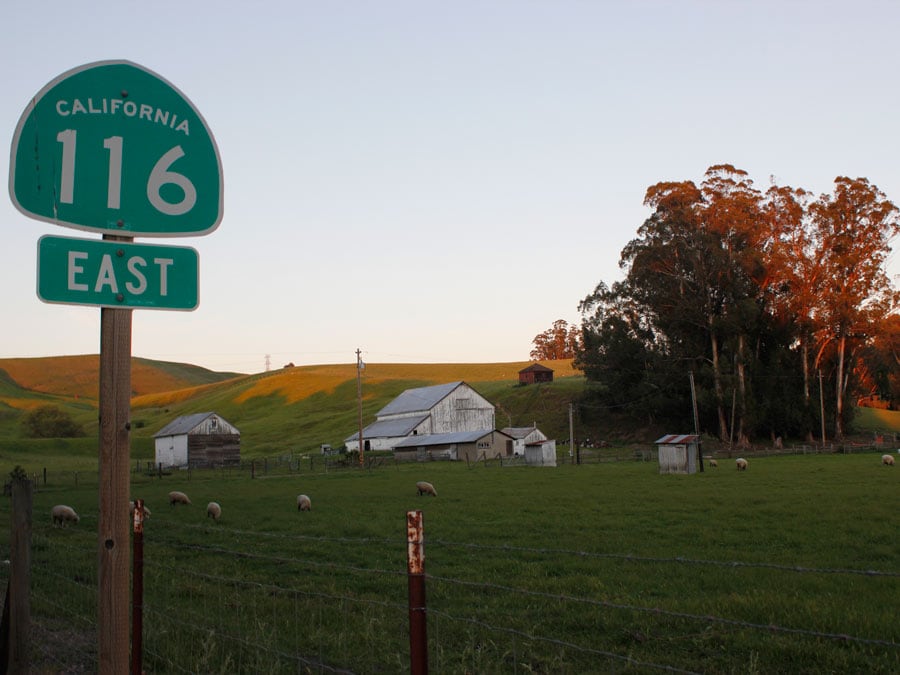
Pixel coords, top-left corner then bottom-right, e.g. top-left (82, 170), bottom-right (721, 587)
top-left (9, 61), bottom-right (223, 237)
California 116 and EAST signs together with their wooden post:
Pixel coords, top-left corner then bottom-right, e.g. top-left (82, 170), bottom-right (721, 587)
top-left (9, 61), bottom-right (223, 675)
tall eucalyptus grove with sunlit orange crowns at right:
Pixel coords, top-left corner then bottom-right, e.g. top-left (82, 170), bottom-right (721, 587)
top-left (544, 165), bottom-right (900, 443)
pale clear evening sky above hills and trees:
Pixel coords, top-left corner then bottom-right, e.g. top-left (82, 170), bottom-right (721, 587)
top-left (0, 0), bottom-right (900, 373)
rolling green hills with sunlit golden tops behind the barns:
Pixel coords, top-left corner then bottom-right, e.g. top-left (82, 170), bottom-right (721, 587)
top-left (0, 355), bottom-right (900, 472)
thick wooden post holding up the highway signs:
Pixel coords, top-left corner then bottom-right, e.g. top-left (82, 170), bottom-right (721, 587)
top-left (97, 282), bottom-right (132, 675)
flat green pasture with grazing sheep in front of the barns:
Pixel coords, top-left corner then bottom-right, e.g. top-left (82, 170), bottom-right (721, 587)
top-left (0, 452), bottom-right (900, 673)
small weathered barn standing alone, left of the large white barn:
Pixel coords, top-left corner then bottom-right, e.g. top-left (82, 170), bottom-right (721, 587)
top-left (153, 412), bottom-right (241, 469)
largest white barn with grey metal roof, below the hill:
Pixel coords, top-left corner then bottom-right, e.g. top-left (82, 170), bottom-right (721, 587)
top-left (344, 382), bottom-right (494, 451)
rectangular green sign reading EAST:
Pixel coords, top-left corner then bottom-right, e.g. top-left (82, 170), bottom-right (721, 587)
top-left (37, 236), bottom-right (200, 310)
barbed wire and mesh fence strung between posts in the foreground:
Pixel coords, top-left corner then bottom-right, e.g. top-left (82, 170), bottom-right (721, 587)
top-left (8, 516), bottom-right (900, 673)
